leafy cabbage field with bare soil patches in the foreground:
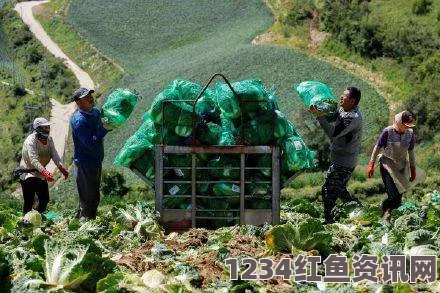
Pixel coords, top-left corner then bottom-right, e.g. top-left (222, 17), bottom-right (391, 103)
top-left (0, 191), bottom-right (440, 292)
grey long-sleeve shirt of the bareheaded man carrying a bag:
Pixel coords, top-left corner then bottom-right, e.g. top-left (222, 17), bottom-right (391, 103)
top-left (318, 107), bottom-right (362, 168)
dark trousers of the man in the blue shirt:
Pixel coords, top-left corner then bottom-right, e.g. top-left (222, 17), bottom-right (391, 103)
top-left (76, 165), bottom-right (102, 219)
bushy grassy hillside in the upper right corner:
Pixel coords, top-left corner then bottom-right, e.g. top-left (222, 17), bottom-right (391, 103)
top-left (267, 0), bottom-right (440, 139)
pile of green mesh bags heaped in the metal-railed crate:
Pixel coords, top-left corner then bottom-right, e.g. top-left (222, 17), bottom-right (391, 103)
top-left (115, 80), bottom-right (316, 224)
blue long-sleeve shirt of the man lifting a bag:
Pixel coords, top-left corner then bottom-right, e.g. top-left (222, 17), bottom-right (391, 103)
top-left (70, 108), bottom-right (108, 166)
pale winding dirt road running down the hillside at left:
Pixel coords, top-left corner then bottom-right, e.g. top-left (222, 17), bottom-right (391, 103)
top-left (14, 1), bottom-right (95, 172)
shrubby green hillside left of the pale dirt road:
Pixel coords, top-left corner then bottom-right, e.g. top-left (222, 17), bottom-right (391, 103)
top-left (0, 1), bottom-right (77, 195)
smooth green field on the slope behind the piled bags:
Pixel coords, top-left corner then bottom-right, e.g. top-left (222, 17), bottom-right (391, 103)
top-left (68, 0), bottom-right (388, 169)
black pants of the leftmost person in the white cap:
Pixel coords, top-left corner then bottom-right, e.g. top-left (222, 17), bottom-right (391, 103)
top-left (20, 177), bottom-right (49, 214)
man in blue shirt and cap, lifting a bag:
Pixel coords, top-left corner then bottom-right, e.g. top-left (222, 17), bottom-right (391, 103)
top-left (70, 88), bottom-right (111, 219)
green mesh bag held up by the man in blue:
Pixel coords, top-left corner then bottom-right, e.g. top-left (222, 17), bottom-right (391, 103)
top-left (102, 89), bottom-right (138, 127)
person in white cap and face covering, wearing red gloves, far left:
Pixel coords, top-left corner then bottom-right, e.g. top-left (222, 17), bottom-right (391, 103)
top-left (20, 117), bottom-right (69, 214)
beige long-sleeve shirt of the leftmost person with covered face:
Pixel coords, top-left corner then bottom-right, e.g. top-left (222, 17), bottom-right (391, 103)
top-left (20, 132), bottom-right (61, 180)
